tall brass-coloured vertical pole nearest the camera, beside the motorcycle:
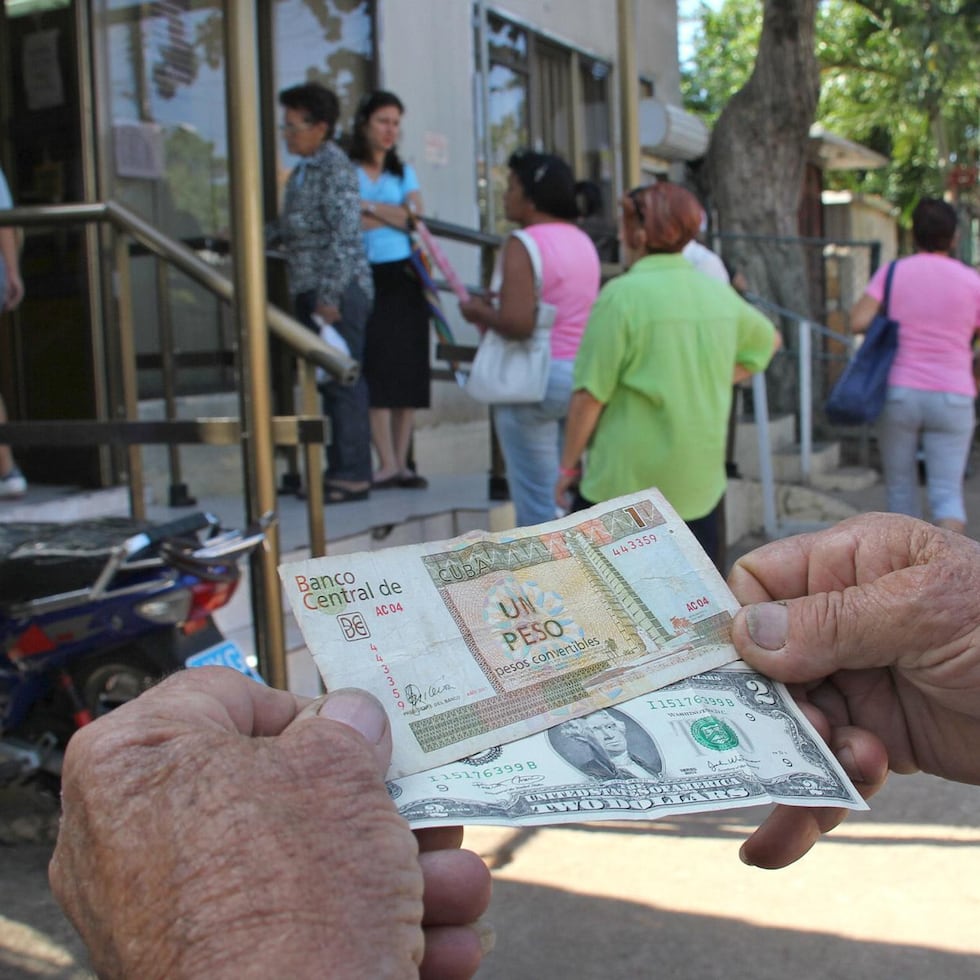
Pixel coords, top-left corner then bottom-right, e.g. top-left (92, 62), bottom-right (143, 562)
top-left (224, 0), bottom-right (287, 689)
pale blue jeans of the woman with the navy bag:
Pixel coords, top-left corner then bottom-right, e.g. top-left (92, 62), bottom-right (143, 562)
top-left (878, 385), bottom-right (976, 521)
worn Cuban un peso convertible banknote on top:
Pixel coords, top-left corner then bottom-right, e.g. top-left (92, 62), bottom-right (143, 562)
top-left (280, 490), bottom-right (737, 777)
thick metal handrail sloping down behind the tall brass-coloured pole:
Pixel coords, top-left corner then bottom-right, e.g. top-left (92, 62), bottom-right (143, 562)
top-left (0, 201), bottom-right (360, 384)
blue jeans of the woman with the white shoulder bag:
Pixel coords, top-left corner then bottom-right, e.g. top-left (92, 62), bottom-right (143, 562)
top-left (493, 361), bottom-right (574, 527)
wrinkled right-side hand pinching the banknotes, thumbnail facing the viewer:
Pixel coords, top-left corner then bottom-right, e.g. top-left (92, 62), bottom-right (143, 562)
top-left (729, 514), bottom-right (980, 868)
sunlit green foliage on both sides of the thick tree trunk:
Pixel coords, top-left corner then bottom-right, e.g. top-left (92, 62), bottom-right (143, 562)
top-left (682, 0), bottom-right (980, 214)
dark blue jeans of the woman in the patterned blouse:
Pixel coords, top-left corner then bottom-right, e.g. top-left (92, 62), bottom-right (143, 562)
top-left (294, 281), bottom-right (371, 483)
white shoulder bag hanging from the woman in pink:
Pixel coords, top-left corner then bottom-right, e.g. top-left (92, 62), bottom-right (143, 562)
top-left (465, 231), bottom-right (556, 405)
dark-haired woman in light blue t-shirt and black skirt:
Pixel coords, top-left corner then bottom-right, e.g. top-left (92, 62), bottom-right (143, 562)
top-left (350, 92), bottom-right (431, 489)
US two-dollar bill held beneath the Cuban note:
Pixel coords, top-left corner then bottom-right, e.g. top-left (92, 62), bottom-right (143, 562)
top-left (388, 662), bottom-right (868, 828)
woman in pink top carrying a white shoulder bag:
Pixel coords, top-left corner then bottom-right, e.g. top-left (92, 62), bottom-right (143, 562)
top-left (459, 152), bottom-right (600, 527)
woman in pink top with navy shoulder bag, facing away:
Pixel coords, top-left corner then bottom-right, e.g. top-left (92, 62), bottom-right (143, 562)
top-left (851, 198), bottom-right (980, 531)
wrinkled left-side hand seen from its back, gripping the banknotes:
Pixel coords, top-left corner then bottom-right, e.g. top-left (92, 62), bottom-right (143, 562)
top-left (50, 668), bottom-right (490, 980)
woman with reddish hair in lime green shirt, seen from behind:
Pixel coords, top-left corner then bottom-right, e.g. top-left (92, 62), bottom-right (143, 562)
top-left (555, 183), bottom-right (780, 561)
